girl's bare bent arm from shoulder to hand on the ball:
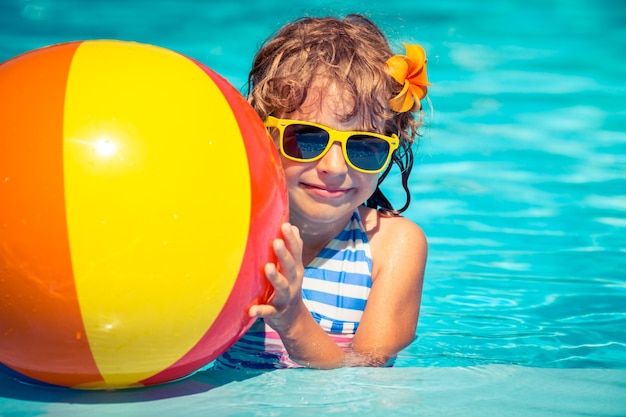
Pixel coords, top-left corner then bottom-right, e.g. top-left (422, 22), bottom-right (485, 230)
top-left (250, 218), bottom-right (426, 369)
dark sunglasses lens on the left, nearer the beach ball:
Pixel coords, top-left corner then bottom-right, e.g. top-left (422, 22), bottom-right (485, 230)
top-left (283, 124), bottom-right (329, 159)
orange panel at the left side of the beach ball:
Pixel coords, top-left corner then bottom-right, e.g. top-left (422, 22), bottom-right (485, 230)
top-left (0, 43), bottom-right (101, 386)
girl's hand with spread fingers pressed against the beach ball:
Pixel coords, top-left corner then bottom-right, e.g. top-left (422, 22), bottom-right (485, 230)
top-left (249, 223), bottom-right (308, 333)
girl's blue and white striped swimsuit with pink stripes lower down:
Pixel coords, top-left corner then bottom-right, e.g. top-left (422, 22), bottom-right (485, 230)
top-left (213, 210), bottom-right (372, 369)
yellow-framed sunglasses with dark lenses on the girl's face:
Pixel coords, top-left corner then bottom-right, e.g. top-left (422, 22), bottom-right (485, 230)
top-left (265, 116), bottom-right (400, 174)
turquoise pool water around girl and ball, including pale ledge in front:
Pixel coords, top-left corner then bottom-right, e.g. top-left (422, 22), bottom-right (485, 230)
top-left (0, 0), bottom-right (626, 417)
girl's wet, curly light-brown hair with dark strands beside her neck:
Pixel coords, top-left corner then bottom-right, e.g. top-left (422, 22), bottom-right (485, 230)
top-left (248, 14), bottom-right (420, 216)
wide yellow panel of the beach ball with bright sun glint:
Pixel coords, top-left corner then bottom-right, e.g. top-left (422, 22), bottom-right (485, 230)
top-left (64, 41), bottom-right (251, 386)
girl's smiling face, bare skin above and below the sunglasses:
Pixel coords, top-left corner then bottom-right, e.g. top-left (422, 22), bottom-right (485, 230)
top-left (281, 80), bottom-right (378, 226)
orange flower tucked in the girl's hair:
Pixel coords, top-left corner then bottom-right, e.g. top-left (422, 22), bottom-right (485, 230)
top-left (387, 43), bottom-right (431, 113)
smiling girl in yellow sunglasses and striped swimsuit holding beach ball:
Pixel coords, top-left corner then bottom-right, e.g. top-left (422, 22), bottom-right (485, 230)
top-left (214, 15), bottom-right (428, 369)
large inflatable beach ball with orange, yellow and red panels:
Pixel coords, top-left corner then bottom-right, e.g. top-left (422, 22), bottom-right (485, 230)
top-left (0, 40), bottom-right (288, 389)
